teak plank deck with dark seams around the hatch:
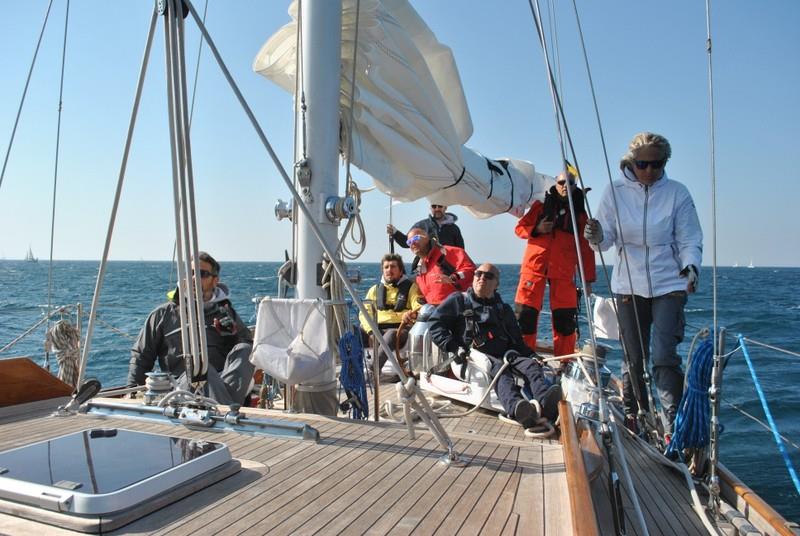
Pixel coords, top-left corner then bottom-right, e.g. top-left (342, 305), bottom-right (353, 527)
top-left (0, 386), bottom-right (704, 535)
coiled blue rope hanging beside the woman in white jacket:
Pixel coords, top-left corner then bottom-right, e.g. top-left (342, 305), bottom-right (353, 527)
top-left (666, 337), bottom-right (714, 455)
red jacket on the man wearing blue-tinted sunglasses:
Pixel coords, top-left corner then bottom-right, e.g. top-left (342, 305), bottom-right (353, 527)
top-left (417, 246), bottom-right (475, 305)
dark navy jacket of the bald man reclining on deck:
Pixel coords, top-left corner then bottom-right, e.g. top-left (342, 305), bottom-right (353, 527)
top-left (428, 288), bottom-right (534, 359)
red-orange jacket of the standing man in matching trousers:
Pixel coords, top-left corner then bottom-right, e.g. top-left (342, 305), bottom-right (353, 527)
top-left (514, 187), bottom-right (597, 283)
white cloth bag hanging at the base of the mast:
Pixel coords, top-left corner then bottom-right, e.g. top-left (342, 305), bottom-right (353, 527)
top-left (250, 297), bottom-right (336, 385)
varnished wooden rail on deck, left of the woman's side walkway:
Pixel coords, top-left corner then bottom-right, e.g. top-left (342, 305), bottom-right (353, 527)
top-left (558, 400), bottom-right (600, 536)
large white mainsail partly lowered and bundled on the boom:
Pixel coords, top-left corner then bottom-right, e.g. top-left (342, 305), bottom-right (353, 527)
top-left (253, 0), bottom-right (553, 218)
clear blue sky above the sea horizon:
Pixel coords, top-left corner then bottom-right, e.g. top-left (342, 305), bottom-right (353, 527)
top-left (0, 0), bottom-right (800, 266)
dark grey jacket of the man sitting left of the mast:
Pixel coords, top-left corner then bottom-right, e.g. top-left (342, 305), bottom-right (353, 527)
top-left (128, 284), bottom-right (253, 385)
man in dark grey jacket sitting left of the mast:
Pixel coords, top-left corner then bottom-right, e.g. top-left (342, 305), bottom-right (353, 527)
top-left (128, 251), bottom-right (254, 404)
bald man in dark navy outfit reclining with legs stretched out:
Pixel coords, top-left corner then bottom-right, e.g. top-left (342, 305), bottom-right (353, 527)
top-left (428, 263), bottom-right (561, 429)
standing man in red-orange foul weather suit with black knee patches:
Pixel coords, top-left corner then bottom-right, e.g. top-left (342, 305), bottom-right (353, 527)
top-left (514, 173), bottom-right (596, 356)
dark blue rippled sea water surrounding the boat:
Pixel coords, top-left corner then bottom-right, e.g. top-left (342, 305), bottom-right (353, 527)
top-left (0, 260), bottom-right (800, 521)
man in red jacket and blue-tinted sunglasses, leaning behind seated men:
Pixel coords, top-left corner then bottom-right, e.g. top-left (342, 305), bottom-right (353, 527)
top-left (407, 228), bottom-right (475, 305)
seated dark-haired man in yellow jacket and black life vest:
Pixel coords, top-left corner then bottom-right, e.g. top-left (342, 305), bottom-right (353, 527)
top-left (358, 253), bottom-right (422, 382)
